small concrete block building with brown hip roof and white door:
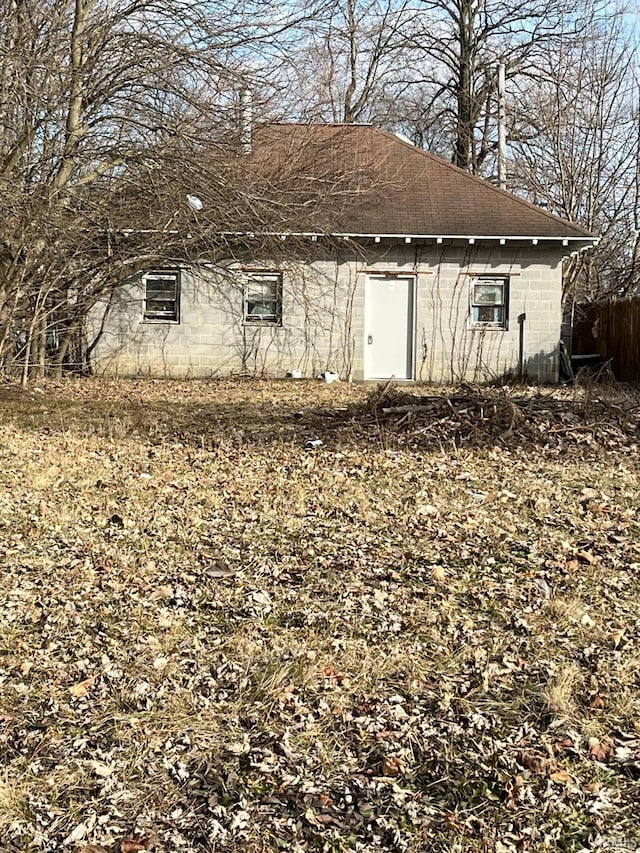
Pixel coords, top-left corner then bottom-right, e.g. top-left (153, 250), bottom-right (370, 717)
top-left (93, 124), bottom-right (594, 382)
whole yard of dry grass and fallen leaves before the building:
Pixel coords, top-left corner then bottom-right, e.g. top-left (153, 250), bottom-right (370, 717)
top-left (0, 380), bottom-right (640, 853)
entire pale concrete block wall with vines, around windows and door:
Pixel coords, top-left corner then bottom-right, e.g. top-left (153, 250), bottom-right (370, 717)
top-left (92, 243), bottom-right (562, 382)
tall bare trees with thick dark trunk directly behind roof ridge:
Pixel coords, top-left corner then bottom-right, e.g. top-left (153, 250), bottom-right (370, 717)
top-left (290, 0), bottom-right (596, 178)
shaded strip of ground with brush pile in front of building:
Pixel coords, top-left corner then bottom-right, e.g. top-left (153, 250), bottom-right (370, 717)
top-left (0, 372), bottom-right (640, 454)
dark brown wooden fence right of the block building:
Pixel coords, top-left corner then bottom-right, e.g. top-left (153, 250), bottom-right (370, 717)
top-left (572, 296), bottom-right (640, 382)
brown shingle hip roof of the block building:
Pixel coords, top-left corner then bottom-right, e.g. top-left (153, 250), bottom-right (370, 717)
top-left (250, 124), bottom-right (593, 241)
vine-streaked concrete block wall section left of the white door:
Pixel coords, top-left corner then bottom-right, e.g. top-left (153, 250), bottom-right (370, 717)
top-left (89, 257), bottom-right (356, 377)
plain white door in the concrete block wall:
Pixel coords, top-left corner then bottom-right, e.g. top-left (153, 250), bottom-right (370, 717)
top-left (364, 275), bottom-right (414, 379)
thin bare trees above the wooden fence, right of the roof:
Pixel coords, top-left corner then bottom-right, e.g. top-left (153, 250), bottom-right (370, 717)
top-left (509, 14), bottom-right (640, 299)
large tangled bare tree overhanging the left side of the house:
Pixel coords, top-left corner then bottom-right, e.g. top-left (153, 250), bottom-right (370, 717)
top-left (0, 0), bottom-right (322, 377)
